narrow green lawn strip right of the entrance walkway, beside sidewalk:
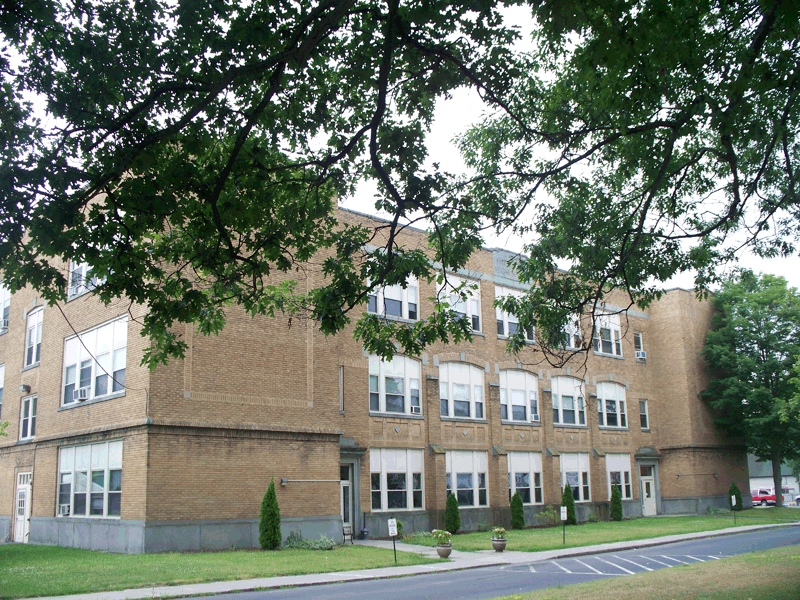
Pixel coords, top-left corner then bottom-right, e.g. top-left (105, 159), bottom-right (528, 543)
top-left (405, 508), bottom-right (800, 552)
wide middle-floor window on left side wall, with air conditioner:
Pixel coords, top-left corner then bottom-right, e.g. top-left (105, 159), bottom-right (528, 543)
top-left (61, 317), bottom-right (128, 405)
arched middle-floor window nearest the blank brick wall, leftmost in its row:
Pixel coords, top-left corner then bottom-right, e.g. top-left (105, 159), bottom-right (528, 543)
top-left (369, 356), bottom-right (422, 415)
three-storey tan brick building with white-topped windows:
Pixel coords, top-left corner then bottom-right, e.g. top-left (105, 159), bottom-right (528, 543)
top-left (0, 211), bottom-right (748, 553)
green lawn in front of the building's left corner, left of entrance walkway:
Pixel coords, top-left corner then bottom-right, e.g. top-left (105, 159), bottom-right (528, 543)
top-left (0, 544), bottom-right (437, 598)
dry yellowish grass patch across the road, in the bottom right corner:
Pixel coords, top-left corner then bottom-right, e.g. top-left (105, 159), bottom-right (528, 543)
top-left (494, 546), bottom-right (800, 600)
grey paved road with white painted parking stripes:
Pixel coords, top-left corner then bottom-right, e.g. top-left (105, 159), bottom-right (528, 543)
top-left (192, 527), bottom-right (800, 600)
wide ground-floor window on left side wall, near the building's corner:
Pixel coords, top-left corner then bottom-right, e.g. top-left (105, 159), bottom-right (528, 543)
top-left (56, 440), bottom-right (122, 517)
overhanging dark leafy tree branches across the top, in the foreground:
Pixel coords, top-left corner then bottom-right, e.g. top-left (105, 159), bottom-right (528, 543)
top-left (0, 0), bottom-right (800, 365)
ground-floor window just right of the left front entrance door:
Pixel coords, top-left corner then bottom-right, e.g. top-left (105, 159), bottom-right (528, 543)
top-left (369, 448), bottom-right (424, 511)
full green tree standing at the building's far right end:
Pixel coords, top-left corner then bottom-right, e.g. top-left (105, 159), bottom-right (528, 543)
top-left (702, 271), bottom-right (800, 506)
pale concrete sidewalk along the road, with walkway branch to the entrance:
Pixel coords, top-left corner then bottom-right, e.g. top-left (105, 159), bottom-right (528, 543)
top-left (29, 523), bottom-right (800, 600)
